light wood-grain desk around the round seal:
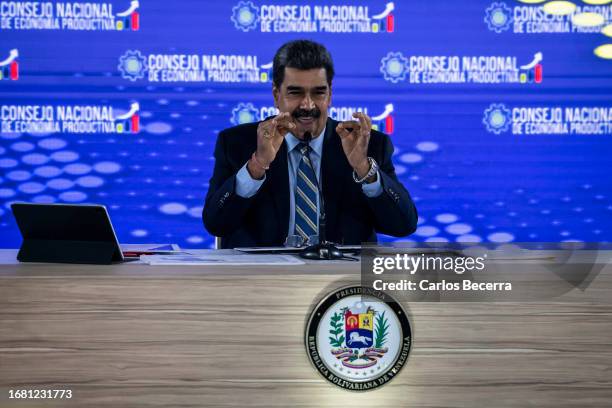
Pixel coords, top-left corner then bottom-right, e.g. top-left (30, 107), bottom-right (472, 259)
top-left (0, 250), bottom-right (612, 407)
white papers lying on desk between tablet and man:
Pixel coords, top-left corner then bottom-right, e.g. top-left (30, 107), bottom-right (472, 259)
top-left (140, 254), bottom-right (304, 266)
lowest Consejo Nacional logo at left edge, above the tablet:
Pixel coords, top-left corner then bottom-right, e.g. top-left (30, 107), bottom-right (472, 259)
top-left (0, 102), bottom-right (140, 134)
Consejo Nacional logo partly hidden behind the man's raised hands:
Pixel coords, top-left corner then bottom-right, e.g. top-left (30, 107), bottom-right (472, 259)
top-left (230, 102), bottom-right (395, 135)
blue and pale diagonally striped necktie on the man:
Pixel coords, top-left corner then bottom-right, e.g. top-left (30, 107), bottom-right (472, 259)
top-left (295, 143), bottom-right (319, 239)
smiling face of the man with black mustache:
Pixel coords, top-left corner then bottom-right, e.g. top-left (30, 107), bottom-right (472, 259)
top-left (272, 68), bottom-right (331, 139)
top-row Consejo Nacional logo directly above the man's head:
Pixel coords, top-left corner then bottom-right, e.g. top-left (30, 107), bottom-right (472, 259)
top-left (231, 1), bottom-right (395, 34)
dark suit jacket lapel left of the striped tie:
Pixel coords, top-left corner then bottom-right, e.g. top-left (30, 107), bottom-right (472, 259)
top-left (270, 142), bottom-right (289, 240)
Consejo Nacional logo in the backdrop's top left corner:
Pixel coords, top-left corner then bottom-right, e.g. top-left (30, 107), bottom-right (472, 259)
top-left (0, 0), bottom-right (140, 31)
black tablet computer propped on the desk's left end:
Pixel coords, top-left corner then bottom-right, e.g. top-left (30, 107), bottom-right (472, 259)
top-left (11, 203), bottom-right (124, 264)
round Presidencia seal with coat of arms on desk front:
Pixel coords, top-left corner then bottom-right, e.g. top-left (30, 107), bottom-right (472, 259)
top-left (306, 286), bottom-right (412, 391)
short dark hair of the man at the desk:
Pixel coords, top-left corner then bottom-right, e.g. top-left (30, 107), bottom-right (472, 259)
top-left (272, 40), bottom-right (334, 88)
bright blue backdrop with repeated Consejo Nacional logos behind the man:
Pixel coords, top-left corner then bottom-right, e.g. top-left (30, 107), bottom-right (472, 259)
top-left (0, 0), bottom-right (612, 247)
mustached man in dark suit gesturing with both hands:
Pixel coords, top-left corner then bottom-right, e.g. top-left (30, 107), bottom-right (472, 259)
top-left (203, 40), bottom-right (417, 248)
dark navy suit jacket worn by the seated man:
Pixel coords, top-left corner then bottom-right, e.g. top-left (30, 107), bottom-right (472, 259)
top-left (202, 119), bottom-right (417, 248)
